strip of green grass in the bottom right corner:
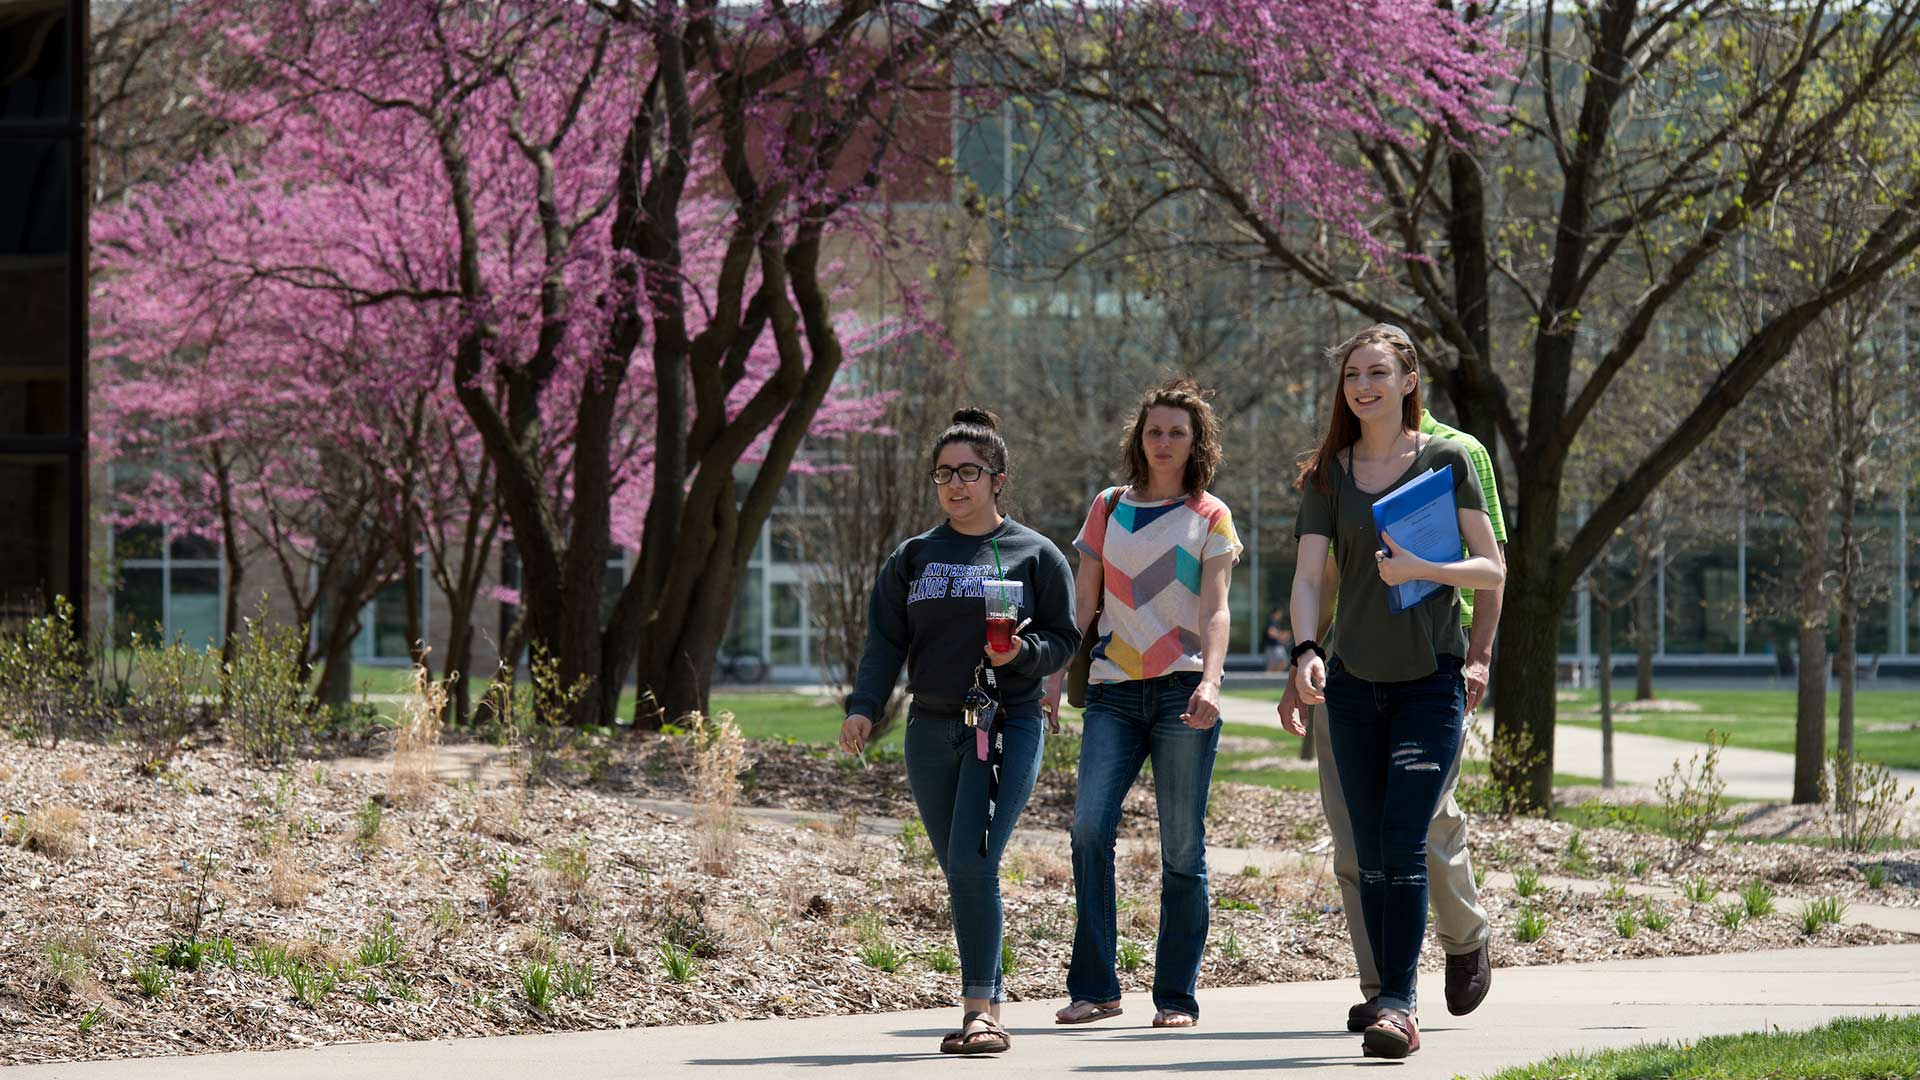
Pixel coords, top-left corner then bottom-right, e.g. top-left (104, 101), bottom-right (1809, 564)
top-left (1486, 1015), bottom-right (1920, 1080)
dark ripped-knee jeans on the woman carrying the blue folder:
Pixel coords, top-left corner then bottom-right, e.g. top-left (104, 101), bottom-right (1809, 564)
top-left (1327, 655), bottom-right (1467, 1011)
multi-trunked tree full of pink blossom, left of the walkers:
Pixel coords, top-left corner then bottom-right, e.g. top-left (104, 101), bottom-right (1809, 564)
top-left (102, 0), bottom-right (921, 719)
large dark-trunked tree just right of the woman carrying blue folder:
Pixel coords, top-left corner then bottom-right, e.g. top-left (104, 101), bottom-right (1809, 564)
top-left (1014, 0), bottom-right (1920, 809)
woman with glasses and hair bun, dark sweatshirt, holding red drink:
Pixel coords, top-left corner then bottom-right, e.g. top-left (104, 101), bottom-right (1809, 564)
top-left (839, 409), bottom-right (1079, 1053)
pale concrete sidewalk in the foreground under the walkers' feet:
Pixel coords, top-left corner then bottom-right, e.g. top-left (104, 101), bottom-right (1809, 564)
top-left (6, 945), bottom-right (1920, 1080)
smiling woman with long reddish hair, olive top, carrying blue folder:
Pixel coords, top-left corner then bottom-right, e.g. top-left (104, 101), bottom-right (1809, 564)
top-left (1281, 325), bottom-right (1505, 1057)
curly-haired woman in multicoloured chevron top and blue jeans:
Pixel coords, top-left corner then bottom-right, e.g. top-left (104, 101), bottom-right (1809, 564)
top-left (1046, 379), bottom-right (1240, 1028)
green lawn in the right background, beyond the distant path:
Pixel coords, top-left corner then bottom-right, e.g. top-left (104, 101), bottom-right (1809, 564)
top-left (1559, 684), bottom-right (1920, 769)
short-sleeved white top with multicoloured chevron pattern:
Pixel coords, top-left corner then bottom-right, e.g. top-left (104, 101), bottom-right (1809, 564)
top-left (1073, 488), bottom-right (1240, 682)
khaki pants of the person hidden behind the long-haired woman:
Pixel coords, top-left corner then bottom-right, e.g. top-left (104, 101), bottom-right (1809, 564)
top-left (1313, 705), bottom-right (1490, 997)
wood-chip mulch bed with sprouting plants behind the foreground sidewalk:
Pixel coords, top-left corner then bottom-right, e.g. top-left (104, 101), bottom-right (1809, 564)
top-left (0, 726), bottom-right (1920, 1065)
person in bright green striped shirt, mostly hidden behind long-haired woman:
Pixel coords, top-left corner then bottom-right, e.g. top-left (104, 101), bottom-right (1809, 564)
top-left (1279, 403), bottom-right (1507, 1032)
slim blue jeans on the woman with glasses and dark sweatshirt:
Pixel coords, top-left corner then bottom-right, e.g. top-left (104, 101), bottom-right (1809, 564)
top-left (906, 701), bottom-right (1044, 1001)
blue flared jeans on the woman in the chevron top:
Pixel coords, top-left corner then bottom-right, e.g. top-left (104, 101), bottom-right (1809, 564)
top-left (1068, 671), bottom-right (1219, 1019)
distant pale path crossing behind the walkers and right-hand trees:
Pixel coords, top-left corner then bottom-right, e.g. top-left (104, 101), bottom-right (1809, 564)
top-left (1219, 694), bottom-right (1920, 801)
